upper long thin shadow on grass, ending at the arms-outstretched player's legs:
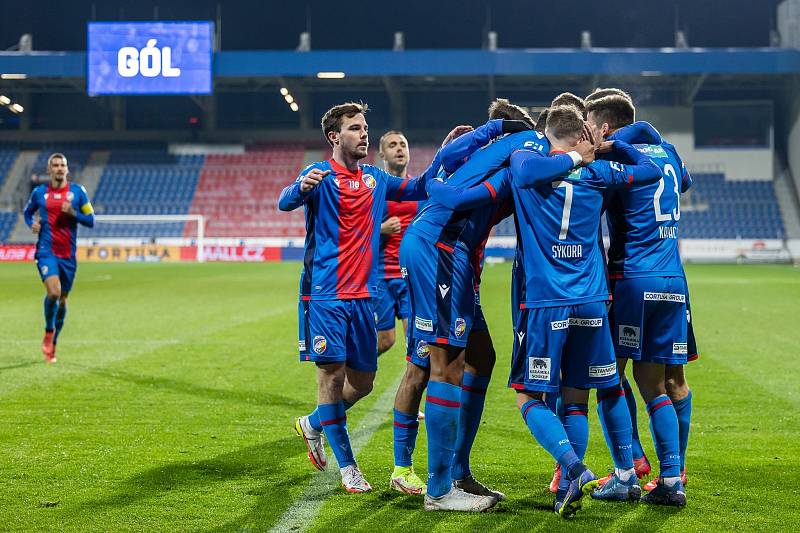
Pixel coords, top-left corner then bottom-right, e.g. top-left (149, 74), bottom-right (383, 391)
top-left (80, 365), bottom-right (309, 411)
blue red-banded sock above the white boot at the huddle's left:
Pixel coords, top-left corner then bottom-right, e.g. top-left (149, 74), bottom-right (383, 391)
top-left (425, 381), bottom-right (461, 498)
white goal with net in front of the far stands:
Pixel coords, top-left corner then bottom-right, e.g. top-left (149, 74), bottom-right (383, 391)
top-left (78, 215), bottom-right (206, 262)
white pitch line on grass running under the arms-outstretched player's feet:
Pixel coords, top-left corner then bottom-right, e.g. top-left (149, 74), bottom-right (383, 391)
top-left (270, 367), bottom-right (405, 533)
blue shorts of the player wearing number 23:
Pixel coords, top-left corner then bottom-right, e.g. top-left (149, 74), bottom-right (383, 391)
top-left (611, 276), bottom-right (688, 365)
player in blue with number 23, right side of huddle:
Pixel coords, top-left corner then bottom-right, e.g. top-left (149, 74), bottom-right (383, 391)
top-left (588, 94), bottom-right (691, 506)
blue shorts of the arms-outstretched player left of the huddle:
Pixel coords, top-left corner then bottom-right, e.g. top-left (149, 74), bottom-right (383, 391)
top-left (298, 298), bottom-right (378, 372)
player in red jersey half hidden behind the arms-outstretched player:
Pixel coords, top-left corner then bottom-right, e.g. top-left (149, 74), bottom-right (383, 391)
top-left (373, 131), bottom-right (420, 355)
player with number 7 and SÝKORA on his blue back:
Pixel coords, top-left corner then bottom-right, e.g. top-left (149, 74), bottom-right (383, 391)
top-left (429, 106), bottom-right (660, 516)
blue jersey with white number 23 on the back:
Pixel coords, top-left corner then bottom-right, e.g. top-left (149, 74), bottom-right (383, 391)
top-left (606, 123), bottom-right (692, 278)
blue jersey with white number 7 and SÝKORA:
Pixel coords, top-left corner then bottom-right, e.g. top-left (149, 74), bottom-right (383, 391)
top-left (512, 142), bottom-right (660, 308)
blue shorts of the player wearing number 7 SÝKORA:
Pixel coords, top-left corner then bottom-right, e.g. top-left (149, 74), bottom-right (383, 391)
top-left (508, 302), bottom-right (619, 392)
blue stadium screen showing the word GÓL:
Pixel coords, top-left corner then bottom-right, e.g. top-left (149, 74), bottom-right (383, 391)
top-left (87, 22), bottom-right (214, 95)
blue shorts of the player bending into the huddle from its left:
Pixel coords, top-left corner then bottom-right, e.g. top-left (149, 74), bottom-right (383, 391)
top-left (400, 233), bottom-right (476, 348)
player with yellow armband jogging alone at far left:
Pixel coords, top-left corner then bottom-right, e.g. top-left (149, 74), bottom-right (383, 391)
top-left (23, 153), bottom-right (94, 363)
